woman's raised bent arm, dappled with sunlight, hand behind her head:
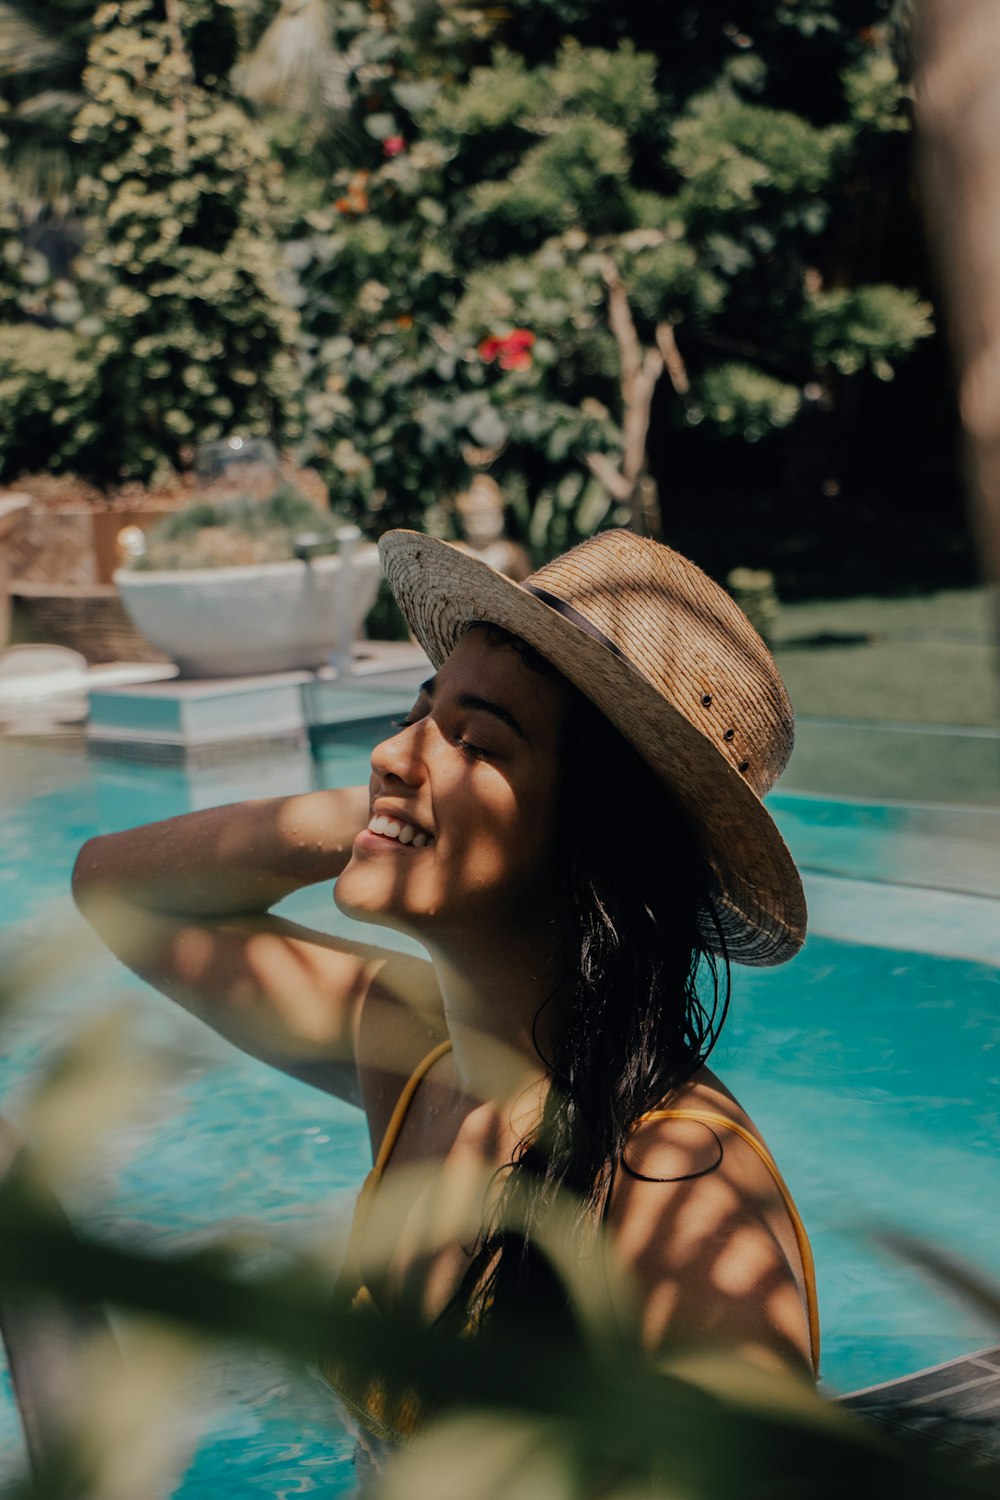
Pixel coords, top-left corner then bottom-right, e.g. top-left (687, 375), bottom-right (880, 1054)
top-left (73, 788), bottom-right (436, 1100)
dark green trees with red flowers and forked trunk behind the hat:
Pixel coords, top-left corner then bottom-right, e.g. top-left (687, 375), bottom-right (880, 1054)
top-left (260, 0), bottom-right (931, 567)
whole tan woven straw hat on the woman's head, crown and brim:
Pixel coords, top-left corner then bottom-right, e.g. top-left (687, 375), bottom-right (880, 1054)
top-left (379, 531), bottom-right (805, 965)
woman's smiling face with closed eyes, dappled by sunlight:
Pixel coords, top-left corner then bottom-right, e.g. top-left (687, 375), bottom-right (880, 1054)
top-left (336, 629), bottom-right (569, 944)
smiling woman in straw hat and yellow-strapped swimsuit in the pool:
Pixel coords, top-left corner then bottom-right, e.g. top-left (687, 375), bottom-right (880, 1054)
top-left (75, 531), bottom-right (817, 1440)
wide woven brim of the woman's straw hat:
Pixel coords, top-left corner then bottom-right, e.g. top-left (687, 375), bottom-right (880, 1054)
top-left (379, 531), bottom-right (807, 966)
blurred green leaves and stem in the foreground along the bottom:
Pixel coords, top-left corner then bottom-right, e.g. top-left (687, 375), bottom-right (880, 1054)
top-left (0, 948), bottom-right (1000, 1500)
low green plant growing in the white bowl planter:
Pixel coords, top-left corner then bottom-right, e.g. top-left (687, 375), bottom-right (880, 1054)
top-left (127, 485), bottom-right (343, 572)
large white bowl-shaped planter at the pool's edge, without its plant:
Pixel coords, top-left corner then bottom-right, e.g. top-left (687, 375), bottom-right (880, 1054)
top-left (114, 543), bottom-right (382, 677)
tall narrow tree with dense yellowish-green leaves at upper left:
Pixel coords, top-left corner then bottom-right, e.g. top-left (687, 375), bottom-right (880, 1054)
top-left (65, 0), bottom-right (298, 477)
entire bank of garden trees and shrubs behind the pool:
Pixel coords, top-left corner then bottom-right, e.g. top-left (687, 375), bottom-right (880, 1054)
top-left (0, 0), bottom-right (931, 573)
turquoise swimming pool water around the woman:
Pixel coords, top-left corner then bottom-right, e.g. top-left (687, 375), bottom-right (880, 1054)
top-left (0, 728), bottom-right (1000, 1500)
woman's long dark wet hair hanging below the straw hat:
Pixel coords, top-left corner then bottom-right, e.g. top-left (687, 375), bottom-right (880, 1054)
top-left (454, 627), bottom-right (730, 1323)
